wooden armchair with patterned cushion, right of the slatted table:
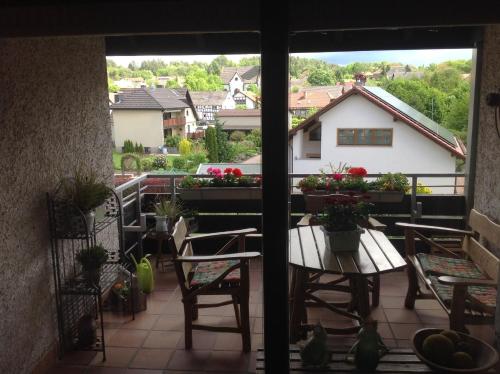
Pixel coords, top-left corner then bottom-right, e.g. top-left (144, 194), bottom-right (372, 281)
top-left (396, 209), bottom-right (500, 332)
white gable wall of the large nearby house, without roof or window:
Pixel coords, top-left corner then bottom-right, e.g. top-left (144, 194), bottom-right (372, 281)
top-left (293, 95), bottom-right (455, 193)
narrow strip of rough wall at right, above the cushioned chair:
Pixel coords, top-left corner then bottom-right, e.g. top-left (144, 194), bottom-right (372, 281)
top-left (474, 25), bottom-right (500, 222)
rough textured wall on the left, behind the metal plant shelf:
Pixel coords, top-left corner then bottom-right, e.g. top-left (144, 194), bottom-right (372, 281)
top-left (0, 38), bottom-right (113, 373)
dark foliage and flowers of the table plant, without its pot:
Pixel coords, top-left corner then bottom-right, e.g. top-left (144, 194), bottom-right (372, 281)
top-left (319, 195), bottom-right (371, 231)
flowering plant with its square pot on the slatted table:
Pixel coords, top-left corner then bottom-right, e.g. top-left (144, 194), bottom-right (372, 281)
top-left (318, 194), bottom-right (370, 252)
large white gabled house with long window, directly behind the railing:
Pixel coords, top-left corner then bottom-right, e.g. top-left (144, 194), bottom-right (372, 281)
top-left (289, 86), bottom-right (465, 193)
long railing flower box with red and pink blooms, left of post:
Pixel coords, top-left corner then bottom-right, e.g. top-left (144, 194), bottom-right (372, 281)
top-left (177, 168), bottom-right (262, 200)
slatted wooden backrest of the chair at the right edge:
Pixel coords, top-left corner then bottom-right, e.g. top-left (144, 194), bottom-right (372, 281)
top-left (462, 209), bottom-right (500, 282)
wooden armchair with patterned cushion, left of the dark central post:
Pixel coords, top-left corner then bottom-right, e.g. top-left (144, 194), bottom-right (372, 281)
top-left (169, 217), bottom-right (260, 352)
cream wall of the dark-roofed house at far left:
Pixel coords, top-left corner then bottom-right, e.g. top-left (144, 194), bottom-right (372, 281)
top-left (113, 109), bottom-right (163, 150)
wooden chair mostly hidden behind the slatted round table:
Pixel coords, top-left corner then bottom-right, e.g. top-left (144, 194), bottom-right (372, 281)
top-left (292, 193), bottom-right (387, 307)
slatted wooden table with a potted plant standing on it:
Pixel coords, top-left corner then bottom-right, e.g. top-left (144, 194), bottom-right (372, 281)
top-left (289, 226), bottom-right (406, 343)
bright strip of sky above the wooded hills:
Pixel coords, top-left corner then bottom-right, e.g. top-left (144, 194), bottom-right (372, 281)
top-left (108, 49), bottom-right (472, 66)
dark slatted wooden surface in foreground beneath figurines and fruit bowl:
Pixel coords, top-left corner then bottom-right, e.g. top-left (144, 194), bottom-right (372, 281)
top-left (256, 346), bottom-right (468, 373)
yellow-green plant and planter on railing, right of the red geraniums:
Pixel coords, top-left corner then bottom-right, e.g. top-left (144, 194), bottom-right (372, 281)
top-left (369, 173), bottom-right (410, 202)
